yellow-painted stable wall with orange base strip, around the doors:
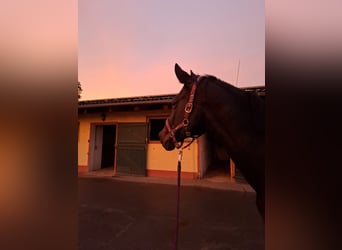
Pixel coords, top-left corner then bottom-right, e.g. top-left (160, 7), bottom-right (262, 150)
top-left (78, 110), bottom-right (198, 178)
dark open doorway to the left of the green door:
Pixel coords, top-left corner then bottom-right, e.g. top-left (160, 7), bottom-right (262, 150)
top-left (89, 124), bottom-right (117, 171)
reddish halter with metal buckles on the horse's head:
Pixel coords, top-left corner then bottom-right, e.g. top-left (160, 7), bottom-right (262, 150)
top-left (165, 76), bottom-right (201, 148)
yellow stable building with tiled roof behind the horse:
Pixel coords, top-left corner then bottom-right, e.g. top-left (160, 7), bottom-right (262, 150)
top-left (78, 87), bottom-right (265, 180)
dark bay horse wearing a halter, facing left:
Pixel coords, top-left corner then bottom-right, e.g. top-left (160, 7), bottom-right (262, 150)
top-left (159, 64), bottom-right (265, 219)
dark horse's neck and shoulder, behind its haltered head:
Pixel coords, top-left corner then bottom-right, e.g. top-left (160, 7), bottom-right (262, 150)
top-left (202, 82), bottom-right (265, 193)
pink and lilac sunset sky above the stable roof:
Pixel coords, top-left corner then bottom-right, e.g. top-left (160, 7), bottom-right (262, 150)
top-left (78, 0), bottom-right (265, 100)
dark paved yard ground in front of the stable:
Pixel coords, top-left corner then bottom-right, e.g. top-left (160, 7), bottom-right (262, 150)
top-left (78, 175), bottom-right (264, 250)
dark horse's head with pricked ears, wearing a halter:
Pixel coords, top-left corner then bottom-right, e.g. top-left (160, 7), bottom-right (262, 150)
top-left (159, 63), bottom-right (204, 151)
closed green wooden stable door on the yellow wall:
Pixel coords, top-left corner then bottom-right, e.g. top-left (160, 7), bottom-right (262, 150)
top-left (116, 123), bottom-right (147, 176)
